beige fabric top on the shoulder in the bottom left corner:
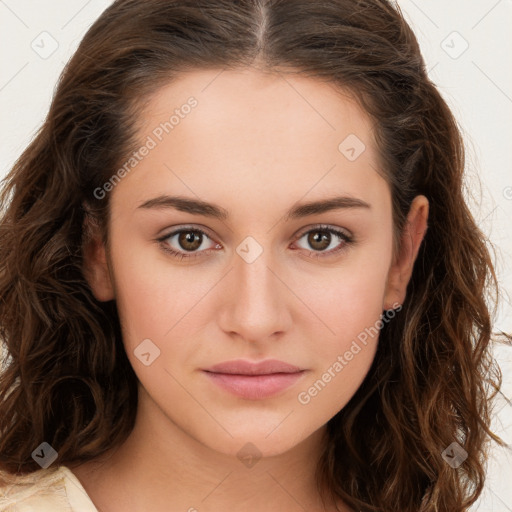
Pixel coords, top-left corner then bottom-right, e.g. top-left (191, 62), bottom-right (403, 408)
top-left (0, 466), bottom-right (98, 512)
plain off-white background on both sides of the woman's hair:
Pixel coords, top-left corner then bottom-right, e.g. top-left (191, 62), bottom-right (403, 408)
top-left (0, 0), bottom-right (512, 512)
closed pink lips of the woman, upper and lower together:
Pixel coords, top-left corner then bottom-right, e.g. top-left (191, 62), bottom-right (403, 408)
top-left (203, 359), bottom-right (307, 400)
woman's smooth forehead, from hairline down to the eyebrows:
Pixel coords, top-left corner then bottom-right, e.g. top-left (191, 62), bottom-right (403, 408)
top-left (114, 69), bottom-right (383, 218)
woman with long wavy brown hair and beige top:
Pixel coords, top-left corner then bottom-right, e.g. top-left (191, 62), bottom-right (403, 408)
top-left (0, 0), bottom-right (508, 512)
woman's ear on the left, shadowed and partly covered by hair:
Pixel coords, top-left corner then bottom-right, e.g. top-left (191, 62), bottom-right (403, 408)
top-left (82, 210), bottom-right (115, 302)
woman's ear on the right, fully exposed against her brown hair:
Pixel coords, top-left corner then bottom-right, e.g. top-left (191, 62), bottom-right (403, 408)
top-left (383, 196), bottom-right (429, 309)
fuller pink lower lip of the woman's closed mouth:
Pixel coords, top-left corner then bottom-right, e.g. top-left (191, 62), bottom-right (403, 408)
top-left (204, 371), bottom-right (304, 400)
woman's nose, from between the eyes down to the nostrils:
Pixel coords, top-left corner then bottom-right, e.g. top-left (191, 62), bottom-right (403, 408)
top-left (218, 244), bottom-right (293, 342)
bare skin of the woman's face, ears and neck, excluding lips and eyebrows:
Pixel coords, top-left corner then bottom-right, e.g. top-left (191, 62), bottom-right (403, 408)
top-left (73, 68), bottom-right (428, 512)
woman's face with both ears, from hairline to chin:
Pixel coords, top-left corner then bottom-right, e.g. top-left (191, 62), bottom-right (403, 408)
top-left (87, 69), bottom-right (427, 455)
